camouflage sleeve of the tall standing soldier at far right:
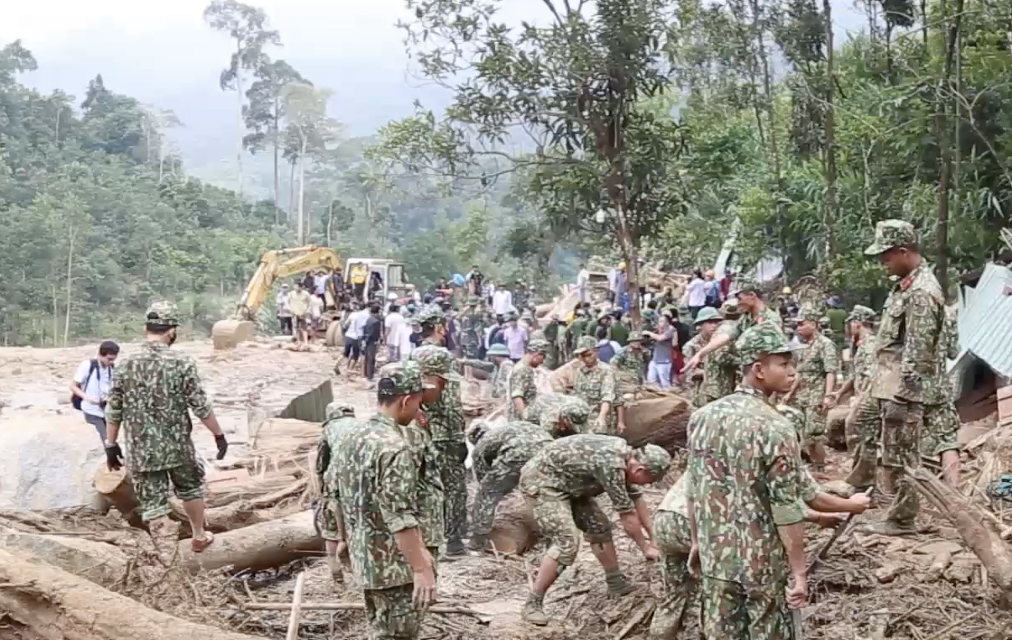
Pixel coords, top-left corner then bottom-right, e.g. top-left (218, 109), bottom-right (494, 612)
top-left (897, 290), bottom-right (942, 402)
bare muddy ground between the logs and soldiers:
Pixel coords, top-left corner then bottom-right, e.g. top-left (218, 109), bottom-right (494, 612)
top-left (0, 342), bottom-right (1012, 640)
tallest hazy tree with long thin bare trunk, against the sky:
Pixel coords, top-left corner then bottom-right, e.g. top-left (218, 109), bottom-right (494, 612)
top-left (203, 0), bottom-right (281, 199)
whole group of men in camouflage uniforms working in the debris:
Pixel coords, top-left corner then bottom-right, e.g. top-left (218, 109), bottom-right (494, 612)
top-left (106, 220), bottom-right (958, 640)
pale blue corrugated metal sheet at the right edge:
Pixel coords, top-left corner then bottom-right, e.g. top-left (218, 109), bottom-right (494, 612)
top-left (957, 264), bottom-right (1012, 378)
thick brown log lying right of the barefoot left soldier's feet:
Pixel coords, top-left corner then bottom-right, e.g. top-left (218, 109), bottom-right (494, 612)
top-left (179, 511), bottom-right (323, 573)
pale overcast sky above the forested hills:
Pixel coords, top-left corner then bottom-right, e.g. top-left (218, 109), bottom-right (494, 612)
top-left (0, 0), bottom-right (861, 179)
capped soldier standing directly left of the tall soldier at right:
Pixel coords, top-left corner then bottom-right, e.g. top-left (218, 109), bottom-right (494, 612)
top-left (834, 305), bottom-right (880, 489)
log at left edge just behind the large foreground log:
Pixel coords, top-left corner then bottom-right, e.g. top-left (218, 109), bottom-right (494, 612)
top-left (0, 530), bottom-right (127, 586)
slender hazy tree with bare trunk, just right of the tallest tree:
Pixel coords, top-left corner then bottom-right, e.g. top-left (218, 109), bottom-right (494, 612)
top-left (243, 60), bottom-right (313, 219)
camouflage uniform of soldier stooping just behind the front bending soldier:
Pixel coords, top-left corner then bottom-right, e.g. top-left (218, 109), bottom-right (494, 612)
top-left (471, 421), bottom-right (552, 536)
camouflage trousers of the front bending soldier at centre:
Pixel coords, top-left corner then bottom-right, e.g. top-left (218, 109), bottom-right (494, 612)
top-left (523, 489), bottom-right (611, 567)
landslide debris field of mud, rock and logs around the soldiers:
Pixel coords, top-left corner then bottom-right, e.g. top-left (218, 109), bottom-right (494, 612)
top-left (0, 341), bottom-right (1012, 640)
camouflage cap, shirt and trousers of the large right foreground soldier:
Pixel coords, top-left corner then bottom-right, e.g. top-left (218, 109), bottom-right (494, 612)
top-left (686, 325), bottom-right (806, 640)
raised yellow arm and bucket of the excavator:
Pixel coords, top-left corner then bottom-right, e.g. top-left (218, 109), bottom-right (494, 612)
top-left (210, 245), bottom-right (341, 349)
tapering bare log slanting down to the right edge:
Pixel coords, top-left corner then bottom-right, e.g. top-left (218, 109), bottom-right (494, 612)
top-left (907, 467), bottom-right (1012, 597)
